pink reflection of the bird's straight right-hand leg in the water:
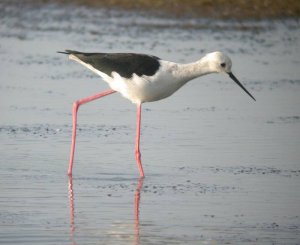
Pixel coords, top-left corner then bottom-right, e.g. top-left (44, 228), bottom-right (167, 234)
top-left (134, 177), bottom-right (144, 245)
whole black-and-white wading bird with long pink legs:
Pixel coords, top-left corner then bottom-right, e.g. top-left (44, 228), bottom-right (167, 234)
top-left (59, 50), bottom-right (255, 177)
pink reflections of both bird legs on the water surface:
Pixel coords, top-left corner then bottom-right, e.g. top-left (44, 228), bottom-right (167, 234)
top-left (68, 175), bottom-right (144, 245)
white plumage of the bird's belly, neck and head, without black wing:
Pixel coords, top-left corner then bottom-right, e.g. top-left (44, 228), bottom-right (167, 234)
top-left (70, 52), bottom-right (231, 104)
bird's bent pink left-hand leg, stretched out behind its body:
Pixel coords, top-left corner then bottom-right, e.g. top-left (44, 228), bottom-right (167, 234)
top-left (68, 89), bottom-right (116, 175)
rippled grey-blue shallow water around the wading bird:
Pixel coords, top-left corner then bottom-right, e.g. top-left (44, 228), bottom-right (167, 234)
top-left (0, 1), bottom-right (300, 244)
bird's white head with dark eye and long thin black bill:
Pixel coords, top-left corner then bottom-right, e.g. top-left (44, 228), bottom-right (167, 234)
top-left (204, 51), bottom-right (255, 100)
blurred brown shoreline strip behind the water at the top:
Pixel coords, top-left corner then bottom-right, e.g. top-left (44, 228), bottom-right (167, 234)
top-left (15, 0), bottom-right (300, 20)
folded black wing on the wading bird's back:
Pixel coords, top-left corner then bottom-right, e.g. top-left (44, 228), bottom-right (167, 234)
top-left (59, 50), bottom-right (160, 78)
